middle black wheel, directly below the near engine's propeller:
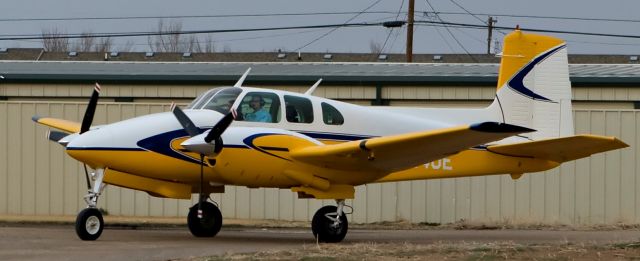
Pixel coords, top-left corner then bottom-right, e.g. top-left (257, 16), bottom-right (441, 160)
top-left (187, 202), bottom-right (222, 237)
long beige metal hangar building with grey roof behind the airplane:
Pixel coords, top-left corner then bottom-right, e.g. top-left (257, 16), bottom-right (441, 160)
top-left (0, 49), bottom-right (640, 225)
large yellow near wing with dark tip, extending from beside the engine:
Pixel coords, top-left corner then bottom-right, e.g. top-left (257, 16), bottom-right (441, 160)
top-left (290, 122), bottom-right (534, 172)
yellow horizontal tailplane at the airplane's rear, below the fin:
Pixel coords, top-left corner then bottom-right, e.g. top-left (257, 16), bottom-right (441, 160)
top-left (487, 135), bottom-right (629, 163)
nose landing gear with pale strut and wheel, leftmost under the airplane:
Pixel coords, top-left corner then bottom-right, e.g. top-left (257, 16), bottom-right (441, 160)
top-left (76, 169), bottom-right (106, 240)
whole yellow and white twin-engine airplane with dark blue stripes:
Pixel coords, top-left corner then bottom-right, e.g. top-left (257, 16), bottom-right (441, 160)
top-left (33, 30), bottom-right (627, 242)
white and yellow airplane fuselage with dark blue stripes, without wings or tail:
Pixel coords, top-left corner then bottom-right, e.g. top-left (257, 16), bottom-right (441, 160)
top-left (62, 87), bottom-right (555, 188)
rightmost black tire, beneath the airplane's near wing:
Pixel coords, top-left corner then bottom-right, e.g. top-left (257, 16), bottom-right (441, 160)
top-left (311, 206), bottom-right (349, 243)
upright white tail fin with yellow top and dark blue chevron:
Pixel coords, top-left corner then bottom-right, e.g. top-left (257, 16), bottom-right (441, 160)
top-left (488, 30), bottom-right (574, 140)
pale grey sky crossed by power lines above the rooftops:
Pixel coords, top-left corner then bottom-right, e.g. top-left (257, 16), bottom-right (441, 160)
top-left (0, 0), bottom-right (640, 54)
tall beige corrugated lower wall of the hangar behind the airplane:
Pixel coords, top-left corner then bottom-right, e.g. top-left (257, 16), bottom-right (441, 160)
top-left (0, 102), bottom-right (640, 224)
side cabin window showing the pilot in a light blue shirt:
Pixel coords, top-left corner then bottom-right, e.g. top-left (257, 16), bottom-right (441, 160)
top-left (236, 92), bottom-right (280, 123)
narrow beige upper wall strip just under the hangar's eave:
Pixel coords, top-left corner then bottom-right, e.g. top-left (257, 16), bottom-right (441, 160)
top-left (0, 83), bottom-right (640, 102)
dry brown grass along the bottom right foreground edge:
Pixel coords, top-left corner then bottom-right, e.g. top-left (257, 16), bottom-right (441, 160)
top-left (190, 242), bottom-right (640, 261)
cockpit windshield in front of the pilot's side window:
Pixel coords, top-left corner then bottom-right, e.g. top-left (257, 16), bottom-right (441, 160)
top-left (187, 87), bottom-right (242, 114)
